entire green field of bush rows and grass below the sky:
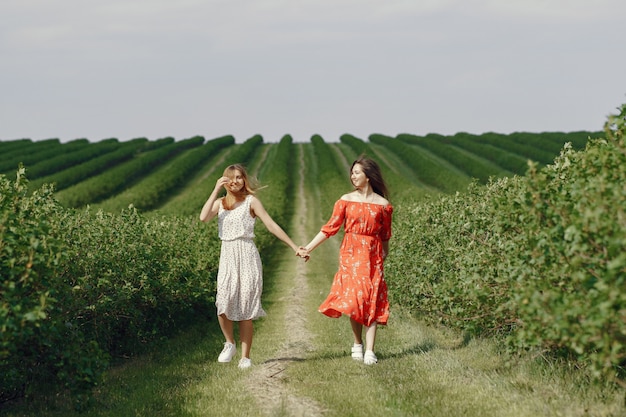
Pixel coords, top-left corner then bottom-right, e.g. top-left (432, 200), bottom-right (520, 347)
top-left (0, 113), bottom-right (626, 416)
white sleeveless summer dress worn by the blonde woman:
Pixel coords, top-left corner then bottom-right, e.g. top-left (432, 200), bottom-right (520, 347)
top-left (215, 195), bottom-right (265, 321)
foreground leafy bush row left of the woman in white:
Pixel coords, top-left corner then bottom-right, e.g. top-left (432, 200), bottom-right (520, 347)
top-left (0, 168), bottom-right (219, 400)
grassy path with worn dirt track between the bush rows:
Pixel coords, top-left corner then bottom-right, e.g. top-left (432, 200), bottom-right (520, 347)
top-left (0, 146), bottom-right (626, 417)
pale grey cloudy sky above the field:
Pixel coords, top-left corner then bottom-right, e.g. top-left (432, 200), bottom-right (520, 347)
top-left (0, 0), bottom-right (626, 142)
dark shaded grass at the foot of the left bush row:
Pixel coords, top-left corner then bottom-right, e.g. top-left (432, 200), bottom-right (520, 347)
top-left (0, 317), bottom-right (223, 417)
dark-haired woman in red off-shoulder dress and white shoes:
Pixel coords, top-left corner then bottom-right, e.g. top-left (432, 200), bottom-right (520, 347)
top-left (304, 157), bottom-right (393, 365)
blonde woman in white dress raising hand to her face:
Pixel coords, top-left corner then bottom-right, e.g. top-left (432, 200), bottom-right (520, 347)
top-left (200, 164), bottom-right (301, 368)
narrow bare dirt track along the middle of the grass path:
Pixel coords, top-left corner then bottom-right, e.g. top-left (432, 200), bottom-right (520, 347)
top-left (247, 148), bottom-right (323, 417)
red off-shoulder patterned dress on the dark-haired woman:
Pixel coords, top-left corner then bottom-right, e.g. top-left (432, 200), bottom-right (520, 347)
top-left (319, 200), bottom-right (393, 326)
